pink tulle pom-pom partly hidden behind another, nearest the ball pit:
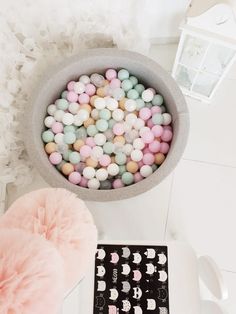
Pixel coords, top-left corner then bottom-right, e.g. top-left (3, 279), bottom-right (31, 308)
top-left (0, 188), bottom-right (97, 290)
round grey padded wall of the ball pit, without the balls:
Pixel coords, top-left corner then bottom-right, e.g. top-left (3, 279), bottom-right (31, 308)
top-left (25, 48), bottom-right (189, 202)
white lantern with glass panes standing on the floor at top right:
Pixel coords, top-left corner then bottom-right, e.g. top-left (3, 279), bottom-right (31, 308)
top-left (172, 3), bottom-right (236, 102)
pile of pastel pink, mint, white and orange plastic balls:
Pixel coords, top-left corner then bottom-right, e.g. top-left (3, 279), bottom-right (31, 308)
top-left (42, 69), bottom-right (172, 189)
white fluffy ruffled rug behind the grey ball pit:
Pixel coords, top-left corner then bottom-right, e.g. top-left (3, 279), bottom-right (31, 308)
top-left (0, 0), bottom-right (149, 185)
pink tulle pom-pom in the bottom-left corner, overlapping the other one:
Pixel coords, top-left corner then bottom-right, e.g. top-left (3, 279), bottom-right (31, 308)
top-left (0, 229), bottom-right (64, 314)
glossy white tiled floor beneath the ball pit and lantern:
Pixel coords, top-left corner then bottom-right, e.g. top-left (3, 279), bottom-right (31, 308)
top-left (8, 45), bottom-right (236, 314)
